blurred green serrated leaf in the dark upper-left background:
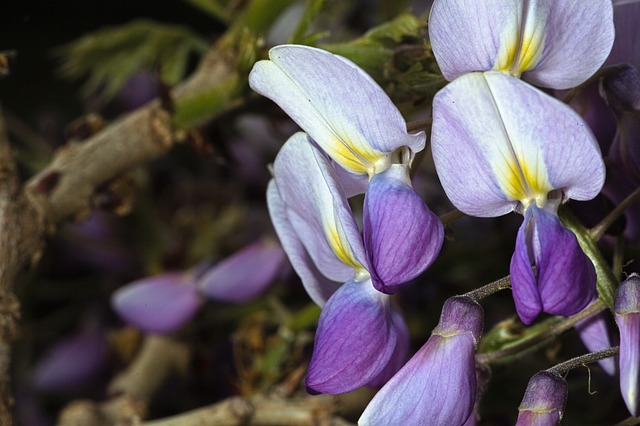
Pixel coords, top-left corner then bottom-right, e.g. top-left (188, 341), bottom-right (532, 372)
top-left (54, 20), bottom-right (208, 101)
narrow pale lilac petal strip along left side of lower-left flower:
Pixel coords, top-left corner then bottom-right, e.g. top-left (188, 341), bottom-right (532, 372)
top-left (267, 179), bottom-right (338, 306)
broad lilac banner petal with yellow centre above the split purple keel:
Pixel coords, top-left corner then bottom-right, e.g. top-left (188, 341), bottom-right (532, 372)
top-left (432, 71), bottom-right (605, 217)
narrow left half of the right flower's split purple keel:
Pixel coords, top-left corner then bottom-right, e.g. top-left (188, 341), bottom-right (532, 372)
top-left (510, 210), bottom-right (542, 324)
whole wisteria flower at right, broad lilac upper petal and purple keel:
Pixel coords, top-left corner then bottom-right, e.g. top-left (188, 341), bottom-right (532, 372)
top-left (432, 71), bottom-right (605, 324)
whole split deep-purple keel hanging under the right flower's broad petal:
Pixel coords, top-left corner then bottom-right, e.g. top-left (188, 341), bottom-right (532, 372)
top-left (511, 204), bottom-right (597, 324)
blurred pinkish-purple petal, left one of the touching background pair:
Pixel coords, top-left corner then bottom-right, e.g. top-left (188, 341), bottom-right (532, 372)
top-left (111, 273), bottom-right (201, 333)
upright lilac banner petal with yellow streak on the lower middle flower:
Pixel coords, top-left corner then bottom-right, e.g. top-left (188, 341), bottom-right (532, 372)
top-left (273, 133), bottom-right (366, 282)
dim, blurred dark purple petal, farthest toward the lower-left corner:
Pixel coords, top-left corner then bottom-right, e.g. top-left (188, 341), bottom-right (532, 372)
top-left (32, 329), bottom-right (107, 392)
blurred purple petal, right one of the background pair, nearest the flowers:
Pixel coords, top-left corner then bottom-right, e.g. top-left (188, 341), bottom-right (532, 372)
top-left (198, 239), bottom-right (285, 303)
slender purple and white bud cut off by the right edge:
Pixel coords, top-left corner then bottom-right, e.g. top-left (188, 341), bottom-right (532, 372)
top-left (614, 274), bottom-right (640, 417)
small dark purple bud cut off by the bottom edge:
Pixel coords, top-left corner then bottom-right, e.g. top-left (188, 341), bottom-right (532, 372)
top-left (516, 371), bottom-right (567, 426)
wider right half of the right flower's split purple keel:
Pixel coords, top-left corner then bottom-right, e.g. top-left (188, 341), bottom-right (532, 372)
top-left (531, 206), bottom-right (597, 316)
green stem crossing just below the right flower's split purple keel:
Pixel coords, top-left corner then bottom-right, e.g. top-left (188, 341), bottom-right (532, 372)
top-left (476, 299), bottom-right (606, 364)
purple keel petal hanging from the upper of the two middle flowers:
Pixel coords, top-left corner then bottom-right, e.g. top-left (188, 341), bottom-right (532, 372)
top-left (363, 164), bottom-right (444, 294)
